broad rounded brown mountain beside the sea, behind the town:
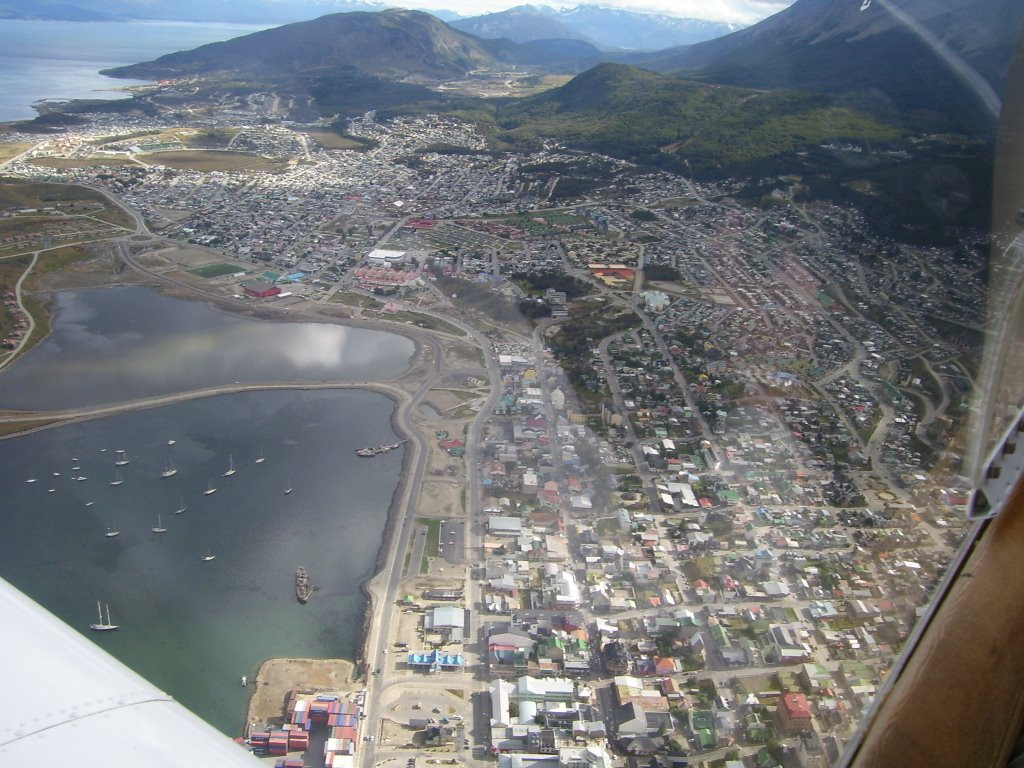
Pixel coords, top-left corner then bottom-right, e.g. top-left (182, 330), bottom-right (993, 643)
top-left (103, 9), bottom-right (495, 82)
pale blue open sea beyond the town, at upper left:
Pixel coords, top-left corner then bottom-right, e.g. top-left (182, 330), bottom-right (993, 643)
top-left (0, 19), bottom-right (264, 122)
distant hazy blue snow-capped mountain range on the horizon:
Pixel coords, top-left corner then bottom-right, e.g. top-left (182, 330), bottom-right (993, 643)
top-left (451, 5), bottom-right (741, 50)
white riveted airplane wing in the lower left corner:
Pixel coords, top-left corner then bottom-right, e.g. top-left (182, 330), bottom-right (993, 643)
top-left (0, 580), bottom-right (260, 768)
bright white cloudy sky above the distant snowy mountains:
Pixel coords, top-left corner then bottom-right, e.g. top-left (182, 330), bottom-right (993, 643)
top-left (411, 0), bottom-right (793, 24)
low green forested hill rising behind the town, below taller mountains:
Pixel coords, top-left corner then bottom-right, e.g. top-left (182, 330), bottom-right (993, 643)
top-left (497, 63), bottom-right (901, 175)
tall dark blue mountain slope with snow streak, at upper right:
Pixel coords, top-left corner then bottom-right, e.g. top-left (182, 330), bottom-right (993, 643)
top-left (632, 0), bottom-right (1024, 133)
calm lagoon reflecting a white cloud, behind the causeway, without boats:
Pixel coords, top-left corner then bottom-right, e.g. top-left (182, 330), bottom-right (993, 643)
top-left (0, 286), bottom-right (416, 410)
